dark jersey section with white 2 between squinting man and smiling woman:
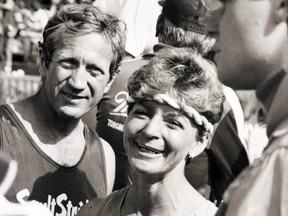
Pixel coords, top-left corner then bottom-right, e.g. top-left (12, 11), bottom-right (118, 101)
top-left (96, 57), bottom-right (148, 190)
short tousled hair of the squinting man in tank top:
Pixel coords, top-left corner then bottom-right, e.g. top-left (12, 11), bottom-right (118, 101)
top-left (39, 4), bottom-right (126, 79)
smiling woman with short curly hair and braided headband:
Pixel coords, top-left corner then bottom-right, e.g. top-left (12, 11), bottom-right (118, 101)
top-left (79, 48), bottom-right (224, 216)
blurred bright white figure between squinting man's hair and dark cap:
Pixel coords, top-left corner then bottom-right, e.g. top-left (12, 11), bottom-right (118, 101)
top-left (93, 0), bottom-right (161, 58)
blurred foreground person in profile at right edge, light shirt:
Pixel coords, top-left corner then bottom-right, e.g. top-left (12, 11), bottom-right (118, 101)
top-left (206, 0), bottom-right (288, 216)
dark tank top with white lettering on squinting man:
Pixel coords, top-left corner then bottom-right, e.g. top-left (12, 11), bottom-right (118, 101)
top-left (0, 105), bottom-right (107, 216)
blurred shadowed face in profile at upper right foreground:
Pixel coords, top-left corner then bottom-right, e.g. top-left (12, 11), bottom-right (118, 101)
top-left (208, 0), bottom-right (287, 89)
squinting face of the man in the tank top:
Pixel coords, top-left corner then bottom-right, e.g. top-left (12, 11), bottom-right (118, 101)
top-left (42, 33), bottom-right (113, 118)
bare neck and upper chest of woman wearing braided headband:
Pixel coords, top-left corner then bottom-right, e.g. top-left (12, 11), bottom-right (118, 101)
top-left (124, 174), bottom-right (204, 216)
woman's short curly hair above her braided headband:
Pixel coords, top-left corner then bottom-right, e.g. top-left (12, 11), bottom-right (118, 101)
top-left (128, 48), bottom-right (225, 133)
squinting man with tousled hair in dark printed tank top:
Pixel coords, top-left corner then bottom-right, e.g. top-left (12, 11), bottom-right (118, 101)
top-left (0, 5), bottom-right (125, 215)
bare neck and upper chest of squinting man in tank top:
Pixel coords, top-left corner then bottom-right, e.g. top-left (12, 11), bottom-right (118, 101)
top-left (11, 95), bottom-right (85, 167)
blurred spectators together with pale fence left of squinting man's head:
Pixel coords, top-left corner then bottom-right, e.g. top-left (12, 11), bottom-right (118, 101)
top-left (0, 0), bottom-right (93, 104)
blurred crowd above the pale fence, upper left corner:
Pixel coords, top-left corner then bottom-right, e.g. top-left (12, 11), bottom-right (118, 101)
top-left (0, 0), bottom-right (93, 74)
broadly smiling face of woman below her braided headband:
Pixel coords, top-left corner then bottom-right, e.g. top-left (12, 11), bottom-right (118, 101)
top-left (124, 101), bottom-right (198, 178)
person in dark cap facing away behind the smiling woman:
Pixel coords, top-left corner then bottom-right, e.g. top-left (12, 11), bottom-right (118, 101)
top-left (96, 0), bottom-right (249, 202)
